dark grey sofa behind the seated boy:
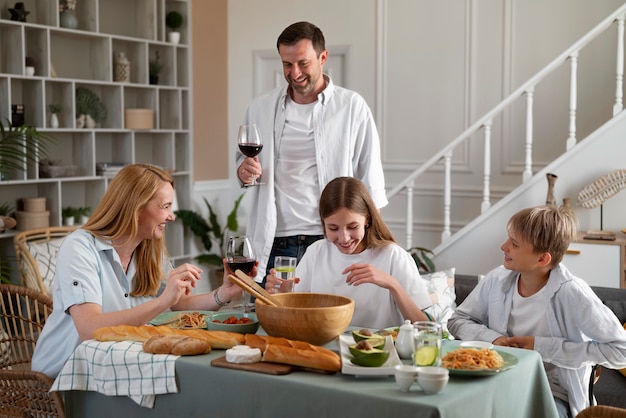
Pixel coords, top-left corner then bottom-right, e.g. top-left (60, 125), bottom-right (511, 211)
top-left (454, 274), bottom-right (626, 408)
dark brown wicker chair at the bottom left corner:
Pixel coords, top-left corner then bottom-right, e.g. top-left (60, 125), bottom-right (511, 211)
top-left (0, 284), bottom-right (65, 417)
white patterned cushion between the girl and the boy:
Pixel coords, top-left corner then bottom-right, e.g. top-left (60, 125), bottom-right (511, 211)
top-left (420, 267), bottom-right (456, 329)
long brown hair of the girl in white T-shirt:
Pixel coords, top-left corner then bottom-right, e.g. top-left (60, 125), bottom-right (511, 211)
top-left (319, 177), bottom-right (396, 248)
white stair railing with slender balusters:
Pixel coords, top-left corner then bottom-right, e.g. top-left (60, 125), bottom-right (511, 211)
top-left (387, 4), bottom-right (626, 248)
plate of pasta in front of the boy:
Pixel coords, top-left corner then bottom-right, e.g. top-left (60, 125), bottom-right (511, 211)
top-left (441, 347), bottom-right (518, 376)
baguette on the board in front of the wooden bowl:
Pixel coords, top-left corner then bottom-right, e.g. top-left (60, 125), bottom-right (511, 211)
top-left (245, 334), bottom-right (341, 372)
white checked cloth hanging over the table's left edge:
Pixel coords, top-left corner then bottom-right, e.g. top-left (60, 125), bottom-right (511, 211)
top-left (50, 340), bottom-right (178, 408)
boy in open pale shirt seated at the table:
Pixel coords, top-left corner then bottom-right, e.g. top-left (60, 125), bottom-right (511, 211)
top-left (448, 206), bottom-right (626, 417)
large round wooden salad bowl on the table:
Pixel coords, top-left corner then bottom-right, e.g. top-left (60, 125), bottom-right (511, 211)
top-left (255, 292), bottom-right (354, 345)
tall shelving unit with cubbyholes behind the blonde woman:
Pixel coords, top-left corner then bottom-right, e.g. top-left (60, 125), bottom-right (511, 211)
top-left (0, 0), bottom-right (192, 262)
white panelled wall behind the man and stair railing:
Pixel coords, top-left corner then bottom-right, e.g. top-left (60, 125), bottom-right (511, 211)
top-left (190, 0), bottom-right (623, 278)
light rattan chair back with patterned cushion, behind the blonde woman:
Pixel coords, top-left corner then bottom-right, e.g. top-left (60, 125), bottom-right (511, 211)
top-left (13, 226), bottom-right (76, 296)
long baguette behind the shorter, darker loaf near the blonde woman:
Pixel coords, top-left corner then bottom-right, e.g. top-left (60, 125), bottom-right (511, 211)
top-left (93, 325), bottom-right (245, 349)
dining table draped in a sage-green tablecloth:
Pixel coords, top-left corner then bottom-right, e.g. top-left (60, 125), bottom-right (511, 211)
top-left (58, 329), bottom-right (558, 418)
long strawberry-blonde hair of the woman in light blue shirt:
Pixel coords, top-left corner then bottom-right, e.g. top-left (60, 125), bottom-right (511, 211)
top-left (82, 164), bottom-right (174, 296)
